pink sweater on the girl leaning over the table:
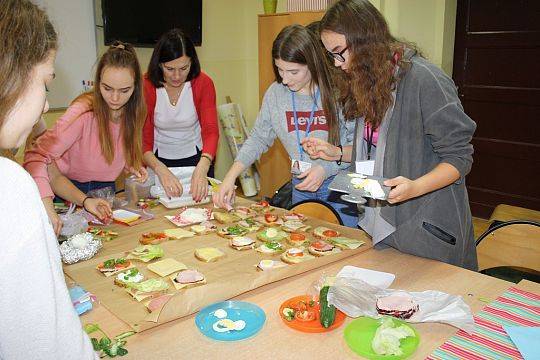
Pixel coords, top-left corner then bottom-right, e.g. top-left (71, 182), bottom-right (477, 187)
top-left (24, 103), bottom-right (126, 198)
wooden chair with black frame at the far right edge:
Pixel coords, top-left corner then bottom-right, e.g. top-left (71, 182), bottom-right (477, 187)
top-left (476, 220), bottom-right (540, 283)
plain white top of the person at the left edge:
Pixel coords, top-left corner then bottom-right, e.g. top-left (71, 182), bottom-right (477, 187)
top-left (0, 157), bottom-right (98, 360)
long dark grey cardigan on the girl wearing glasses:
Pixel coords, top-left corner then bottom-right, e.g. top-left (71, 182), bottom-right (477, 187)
top-left (353, 51), bottom-right (478, 270)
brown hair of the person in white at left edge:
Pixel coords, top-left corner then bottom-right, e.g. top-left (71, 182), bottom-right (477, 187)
top-left (0, 0), bottom-right (57, 127)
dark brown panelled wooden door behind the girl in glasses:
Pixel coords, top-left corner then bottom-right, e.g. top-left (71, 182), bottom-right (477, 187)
top-left (453, 0), bottom-right (540, 218)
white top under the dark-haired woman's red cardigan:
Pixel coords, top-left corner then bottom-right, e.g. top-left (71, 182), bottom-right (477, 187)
top-left (154, 81), bottom-right (202, 160)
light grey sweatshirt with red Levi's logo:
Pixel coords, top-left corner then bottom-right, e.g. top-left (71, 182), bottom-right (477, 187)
top-left (235, 82), bottom-right (354, 178)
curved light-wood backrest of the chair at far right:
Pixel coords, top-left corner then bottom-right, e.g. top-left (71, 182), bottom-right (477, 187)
top-left (476, 220), bottom-right (540, 271)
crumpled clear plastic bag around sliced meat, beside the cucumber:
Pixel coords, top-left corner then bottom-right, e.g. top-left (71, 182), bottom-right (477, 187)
top-left (328, 277), bottom-right (474, 332)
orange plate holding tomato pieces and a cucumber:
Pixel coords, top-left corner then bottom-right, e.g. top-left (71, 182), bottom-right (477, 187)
top-left (279, 295), bottom-right (345, 333)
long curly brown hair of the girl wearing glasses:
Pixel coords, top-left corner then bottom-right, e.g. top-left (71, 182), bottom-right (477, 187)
top-left (320, 0), bottom-right (416, 129)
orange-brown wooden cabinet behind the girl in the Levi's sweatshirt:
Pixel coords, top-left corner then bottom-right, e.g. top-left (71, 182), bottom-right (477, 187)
top-left (257, 11), bottom-right (324, 197)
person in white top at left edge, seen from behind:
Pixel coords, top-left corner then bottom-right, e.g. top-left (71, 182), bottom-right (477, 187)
top-left (0, 0), bottom-right (98, 360)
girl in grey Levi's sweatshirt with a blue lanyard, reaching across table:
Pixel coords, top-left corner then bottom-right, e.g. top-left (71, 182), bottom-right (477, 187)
top-left (214, 25), bottom-right (357, 227)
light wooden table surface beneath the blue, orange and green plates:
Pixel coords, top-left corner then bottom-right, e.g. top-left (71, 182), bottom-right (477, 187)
top-left (68, 201), bottom-right (540, 360)
